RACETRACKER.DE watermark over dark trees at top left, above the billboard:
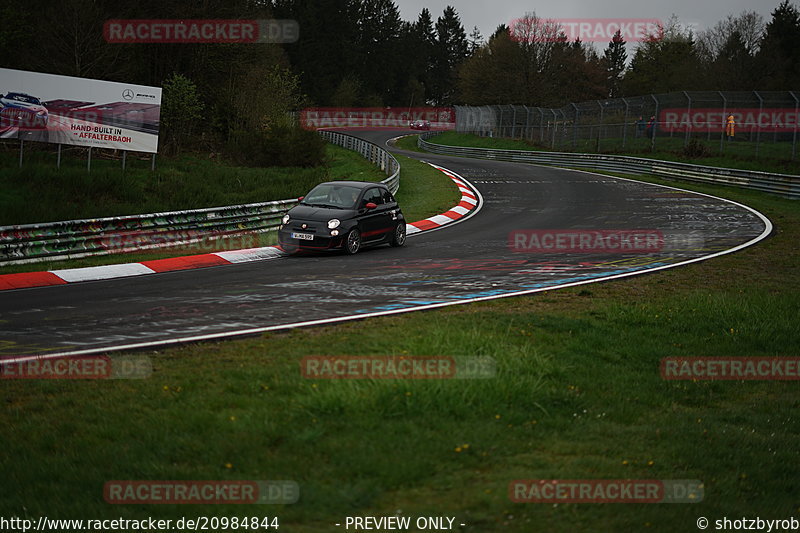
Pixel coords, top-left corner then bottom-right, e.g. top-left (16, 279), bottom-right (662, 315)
top-left (103, 19), bottom-right (300, 44)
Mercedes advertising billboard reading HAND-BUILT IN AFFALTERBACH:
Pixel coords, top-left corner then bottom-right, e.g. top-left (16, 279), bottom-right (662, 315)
top-left (0, 68), bottom-right (161, 153)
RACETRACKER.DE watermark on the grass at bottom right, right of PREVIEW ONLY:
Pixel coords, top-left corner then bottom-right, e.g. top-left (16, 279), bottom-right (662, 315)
top-left (508, 479), bottom-right (704, 504)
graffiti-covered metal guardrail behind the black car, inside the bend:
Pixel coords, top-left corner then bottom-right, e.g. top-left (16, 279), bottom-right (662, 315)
top-left (0, 131), bottom-right (400, 264)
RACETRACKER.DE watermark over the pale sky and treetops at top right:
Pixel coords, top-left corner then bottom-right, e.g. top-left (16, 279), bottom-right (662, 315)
top-left (508, 17), bottom-right (664, 43)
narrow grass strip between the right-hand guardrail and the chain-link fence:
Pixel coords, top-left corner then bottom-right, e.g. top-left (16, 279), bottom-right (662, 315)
top-left (418, 131), bottom-right (800, 175)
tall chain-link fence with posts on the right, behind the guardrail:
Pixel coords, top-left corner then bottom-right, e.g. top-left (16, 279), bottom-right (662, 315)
top-left (456, 91), bottom-right (800, 160)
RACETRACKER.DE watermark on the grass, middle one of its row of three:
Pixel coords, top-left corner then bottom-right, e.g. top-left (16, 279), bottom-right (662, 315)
top-left (300, 355), bottom-right (497, 379)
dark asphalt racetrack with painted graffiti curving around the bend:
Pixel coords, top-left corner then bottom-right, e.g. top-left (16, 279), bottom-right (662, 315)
top-left (0, 130), bottom-right (772, 359)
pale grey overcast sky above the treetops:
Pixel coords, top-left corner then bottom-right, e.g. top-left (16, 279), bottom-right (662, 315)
top-left (395, 0), bottom-right (784, 52)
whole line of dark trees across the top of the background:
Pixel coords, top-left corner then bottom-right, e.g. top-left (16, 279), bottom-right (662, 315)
top-left (0, 0), bottom-right (800, 160)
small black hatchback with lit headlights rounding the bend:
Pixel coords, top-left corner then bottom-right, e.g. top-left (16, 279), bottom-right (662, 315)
top-left (278, 181), bottom-right (406, 254)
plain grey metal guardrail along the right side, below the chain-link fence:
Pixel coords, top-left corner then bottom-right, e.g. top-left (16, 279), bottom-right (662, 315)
top-left (417, 132), bottom-right (800, 199)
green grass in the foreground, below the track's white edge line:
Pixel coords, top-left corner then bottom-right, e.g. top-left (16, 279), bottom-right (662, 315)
top-left (0, 164), bottom-right (800, 533)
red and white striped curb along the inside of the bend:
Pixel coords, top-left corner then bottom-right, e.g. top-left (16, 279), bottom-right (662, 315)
top-left (0, 163), bottom-right (481, 291)
